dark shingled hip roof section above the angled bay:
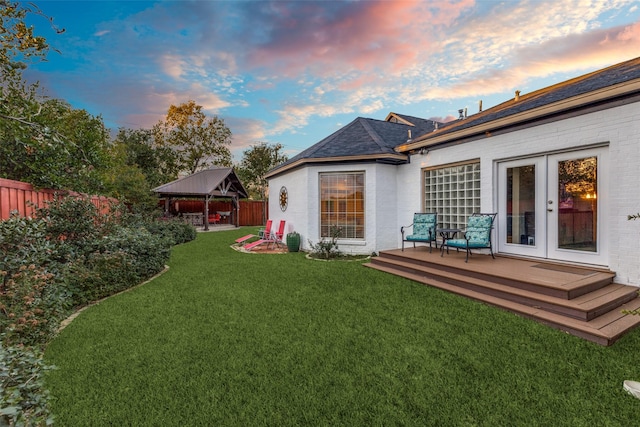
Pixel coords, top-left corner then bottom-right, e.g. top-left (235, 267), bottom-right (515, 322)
top-left (269, 116), bottom-right (435, 175)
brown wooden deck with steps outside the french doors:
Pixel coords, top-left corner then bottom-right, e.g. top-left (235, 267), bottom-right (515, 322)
top-left (365, 246), bottom-right (640, 345)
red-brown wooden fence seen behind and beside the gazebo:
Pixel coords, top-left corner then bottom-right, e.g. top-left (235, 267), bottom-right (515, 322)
top-left (168, 199), bottom-right (269, 226)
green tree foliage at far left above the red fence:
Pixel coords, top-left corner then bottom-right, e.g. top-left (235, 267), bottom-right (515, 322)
top-left (0, 0), bottom-right (114, 192)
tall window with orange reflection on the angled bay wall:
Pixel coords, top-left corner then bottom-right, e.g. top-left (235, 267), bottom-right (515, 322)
top-left (320, 172), bottom-right (365, 239)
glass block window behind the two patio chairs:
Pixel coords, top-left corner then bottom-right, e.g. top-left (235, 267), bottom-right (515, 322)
top-left (424, 162), bottom-right (480, 228)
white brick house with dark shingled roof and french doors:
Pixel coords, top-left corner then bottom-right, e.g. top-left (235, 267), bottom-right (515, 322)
top-left (268, 58), bottom-right (640, 285)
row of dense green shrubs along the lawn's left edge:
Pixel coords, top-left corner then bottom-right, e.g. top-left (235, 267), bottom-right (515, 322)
top-left (0, 198), bottom-right (196, 426)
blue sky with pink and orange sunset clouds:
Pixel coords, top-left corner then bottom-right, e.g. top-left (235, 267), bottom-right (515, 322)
top-left (22, 0), bottom-right (640, 161)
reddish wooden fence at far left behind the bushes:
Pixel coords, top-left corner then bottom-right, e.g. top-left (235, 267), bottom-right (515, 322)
top-left (0, 178), bottom-right (118, 220)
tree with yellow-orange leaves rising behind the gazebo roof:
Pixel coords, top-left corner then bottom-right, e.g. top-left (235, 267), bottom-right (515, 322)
top-left (153, 101), bottom-right (231, 173)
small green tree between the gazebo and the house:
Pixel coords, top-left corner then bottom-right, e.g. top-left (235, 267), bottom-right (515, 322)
top-left (236, 142), bottom-right (288, 200)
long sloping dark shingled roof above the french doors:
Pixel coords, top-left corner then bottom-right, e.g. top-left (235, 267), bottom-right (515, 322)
top-left (414, 58), bottom-right (640, 146)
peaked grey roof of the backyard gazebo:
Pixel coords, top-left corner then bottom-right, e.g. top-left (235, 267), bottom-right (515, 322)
top-left (152, 167), bottom-right (248, 198)
